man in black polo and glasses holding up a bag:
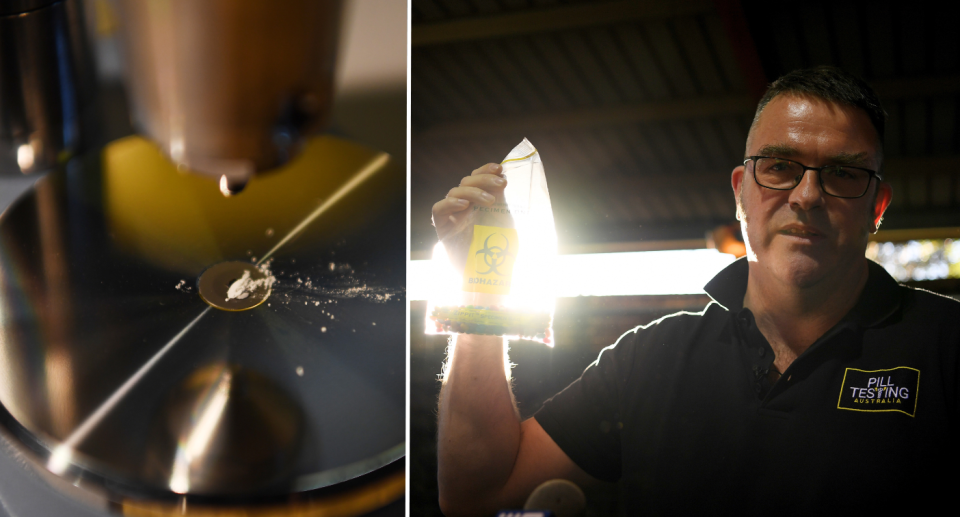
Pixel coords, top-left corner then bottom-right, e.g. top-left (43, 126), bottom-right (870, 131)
top-left (433, 67), bottom-right (960, 515)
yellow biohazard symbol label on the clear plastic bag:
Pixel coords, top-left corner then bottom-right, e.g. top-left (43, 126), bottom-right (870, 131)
top-left (463, 224), bottom-right (520, 294)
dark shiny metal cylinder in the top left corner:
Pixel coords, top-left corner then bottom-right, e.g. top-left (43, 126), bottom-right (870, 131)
top-left (0, 0), bottom-right (95, 174)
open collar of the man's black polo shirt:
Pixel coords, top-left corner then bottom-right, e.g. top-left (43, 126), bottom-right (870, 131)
top-left (703, 257), bottom-right (900, 327)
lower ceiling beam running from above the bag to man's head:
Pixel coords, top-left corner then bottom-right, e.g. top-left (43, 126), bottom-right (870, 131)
top-left (414, 94), bottom-right (756, 140)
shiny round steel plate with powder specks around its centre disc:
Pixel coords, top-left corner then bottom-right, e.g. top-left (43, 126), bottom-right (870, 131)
top-left (0, 133), bottom-right (406, 500)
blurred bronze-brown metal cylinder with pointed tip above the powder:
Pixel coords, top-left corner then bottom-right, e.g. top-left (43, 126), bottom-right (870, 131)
top-left (119, 0), bottom-right (340, 185)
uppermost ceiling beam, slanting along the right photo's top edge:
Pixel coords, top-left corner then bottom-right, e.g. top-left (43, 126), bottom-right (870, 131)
top-left (410, 0), bottom-right (714, 47)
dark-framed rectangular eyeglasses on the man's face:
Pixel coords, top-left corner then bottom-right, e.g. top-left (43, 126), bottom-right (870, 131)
top-left (743, 156), bottom-right (880, 199)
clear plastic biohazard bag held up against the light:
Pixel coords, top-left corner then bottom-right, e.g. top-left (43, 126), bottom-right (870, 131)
top-left (426, 139), bottom-right (557, 346)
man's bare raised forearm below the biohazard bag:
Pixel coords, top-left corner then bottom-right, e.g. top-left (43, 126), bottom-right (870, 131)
top-left (437, 335), bottom-right (520, 515)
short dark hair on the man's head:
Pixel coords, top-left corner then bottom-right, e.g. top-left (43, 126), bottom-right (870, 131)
top-left (751, 66), bottom-right (887, 163)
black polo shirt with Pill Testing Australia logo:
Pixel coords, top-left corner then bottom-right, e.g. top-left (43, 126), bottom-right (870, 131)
top-left (536, 260), bottom-right (960, 515)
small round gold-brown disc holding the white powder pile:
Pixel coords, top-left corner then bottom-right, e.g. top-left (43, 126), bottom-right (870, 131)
top-left (197, 261), bottom-right (272, 311)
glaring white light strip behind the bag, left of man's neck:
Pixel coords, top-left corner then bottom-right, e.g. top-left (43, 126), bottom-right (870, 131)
top-left (408, 249), bottom-right (736, 300)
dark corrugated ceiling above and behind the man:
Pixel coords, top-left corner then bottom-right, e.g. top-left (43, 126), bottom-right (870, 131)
top-left (410, 0), bottom-right (960, 258)
